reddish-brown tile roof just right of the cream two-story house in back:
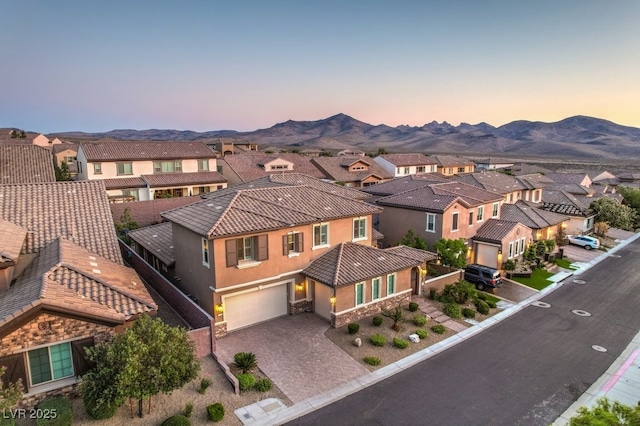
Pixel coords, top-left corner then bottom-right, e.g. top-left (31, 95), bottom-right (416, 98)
top-left (218, 153), bottom-right (326, 182)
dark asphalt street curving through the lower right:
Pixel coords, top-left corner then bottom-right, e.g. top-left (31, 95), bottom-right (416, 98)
top-left (291, 240), bottom-right (640, 425)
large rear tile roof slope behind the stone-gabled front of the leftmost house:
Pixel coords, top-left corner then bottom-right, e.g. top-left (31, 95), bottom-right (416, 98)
top-left (0, 181), bottom-right (122, 264)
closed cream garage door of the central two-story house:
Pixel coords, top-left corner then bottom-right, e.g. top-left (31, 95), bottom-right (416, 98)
top-left (224, 283), bottom-right (288, 331)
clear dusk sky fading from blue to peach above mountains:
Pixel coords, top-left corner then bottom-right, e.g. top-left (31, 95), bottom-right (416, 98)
top-left (0, 0), bottom-right (640, 133)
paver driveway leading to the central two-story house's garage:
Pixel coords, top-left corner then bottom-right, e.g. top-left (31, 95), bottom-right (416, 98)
top-left (216, 314), bottom-right (369, 403)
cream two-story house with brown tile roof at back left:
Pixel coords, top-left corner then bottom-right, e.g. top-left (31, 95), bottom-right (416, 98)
top-left (77, 141), bottom-right (227, 202)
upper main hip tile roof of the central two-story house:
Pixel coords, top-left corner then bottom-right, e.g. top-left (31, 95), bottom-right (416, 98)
top-left (161, 186), bottom-right (381, 237)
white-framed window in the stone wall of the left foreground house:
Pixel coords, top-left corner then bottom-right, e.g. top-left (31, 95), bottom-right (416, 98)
top-left (28, 342), bottom-right (73, 385)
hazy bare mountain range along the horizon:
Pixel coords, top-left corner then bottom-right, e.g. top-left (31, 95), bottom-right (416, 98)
top-left (51, 114), bottom-right (640, 160)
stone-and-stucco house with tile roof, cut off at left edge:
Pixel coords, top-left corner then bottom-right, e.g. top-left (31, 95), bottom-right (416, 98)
top-left (0, 182), bottom-right (157, 406)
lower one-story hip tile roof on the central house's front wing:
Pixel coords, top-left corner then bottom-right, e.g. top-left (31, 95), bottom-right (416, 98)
top-left (302, 242), bottom-right (435, 287)
